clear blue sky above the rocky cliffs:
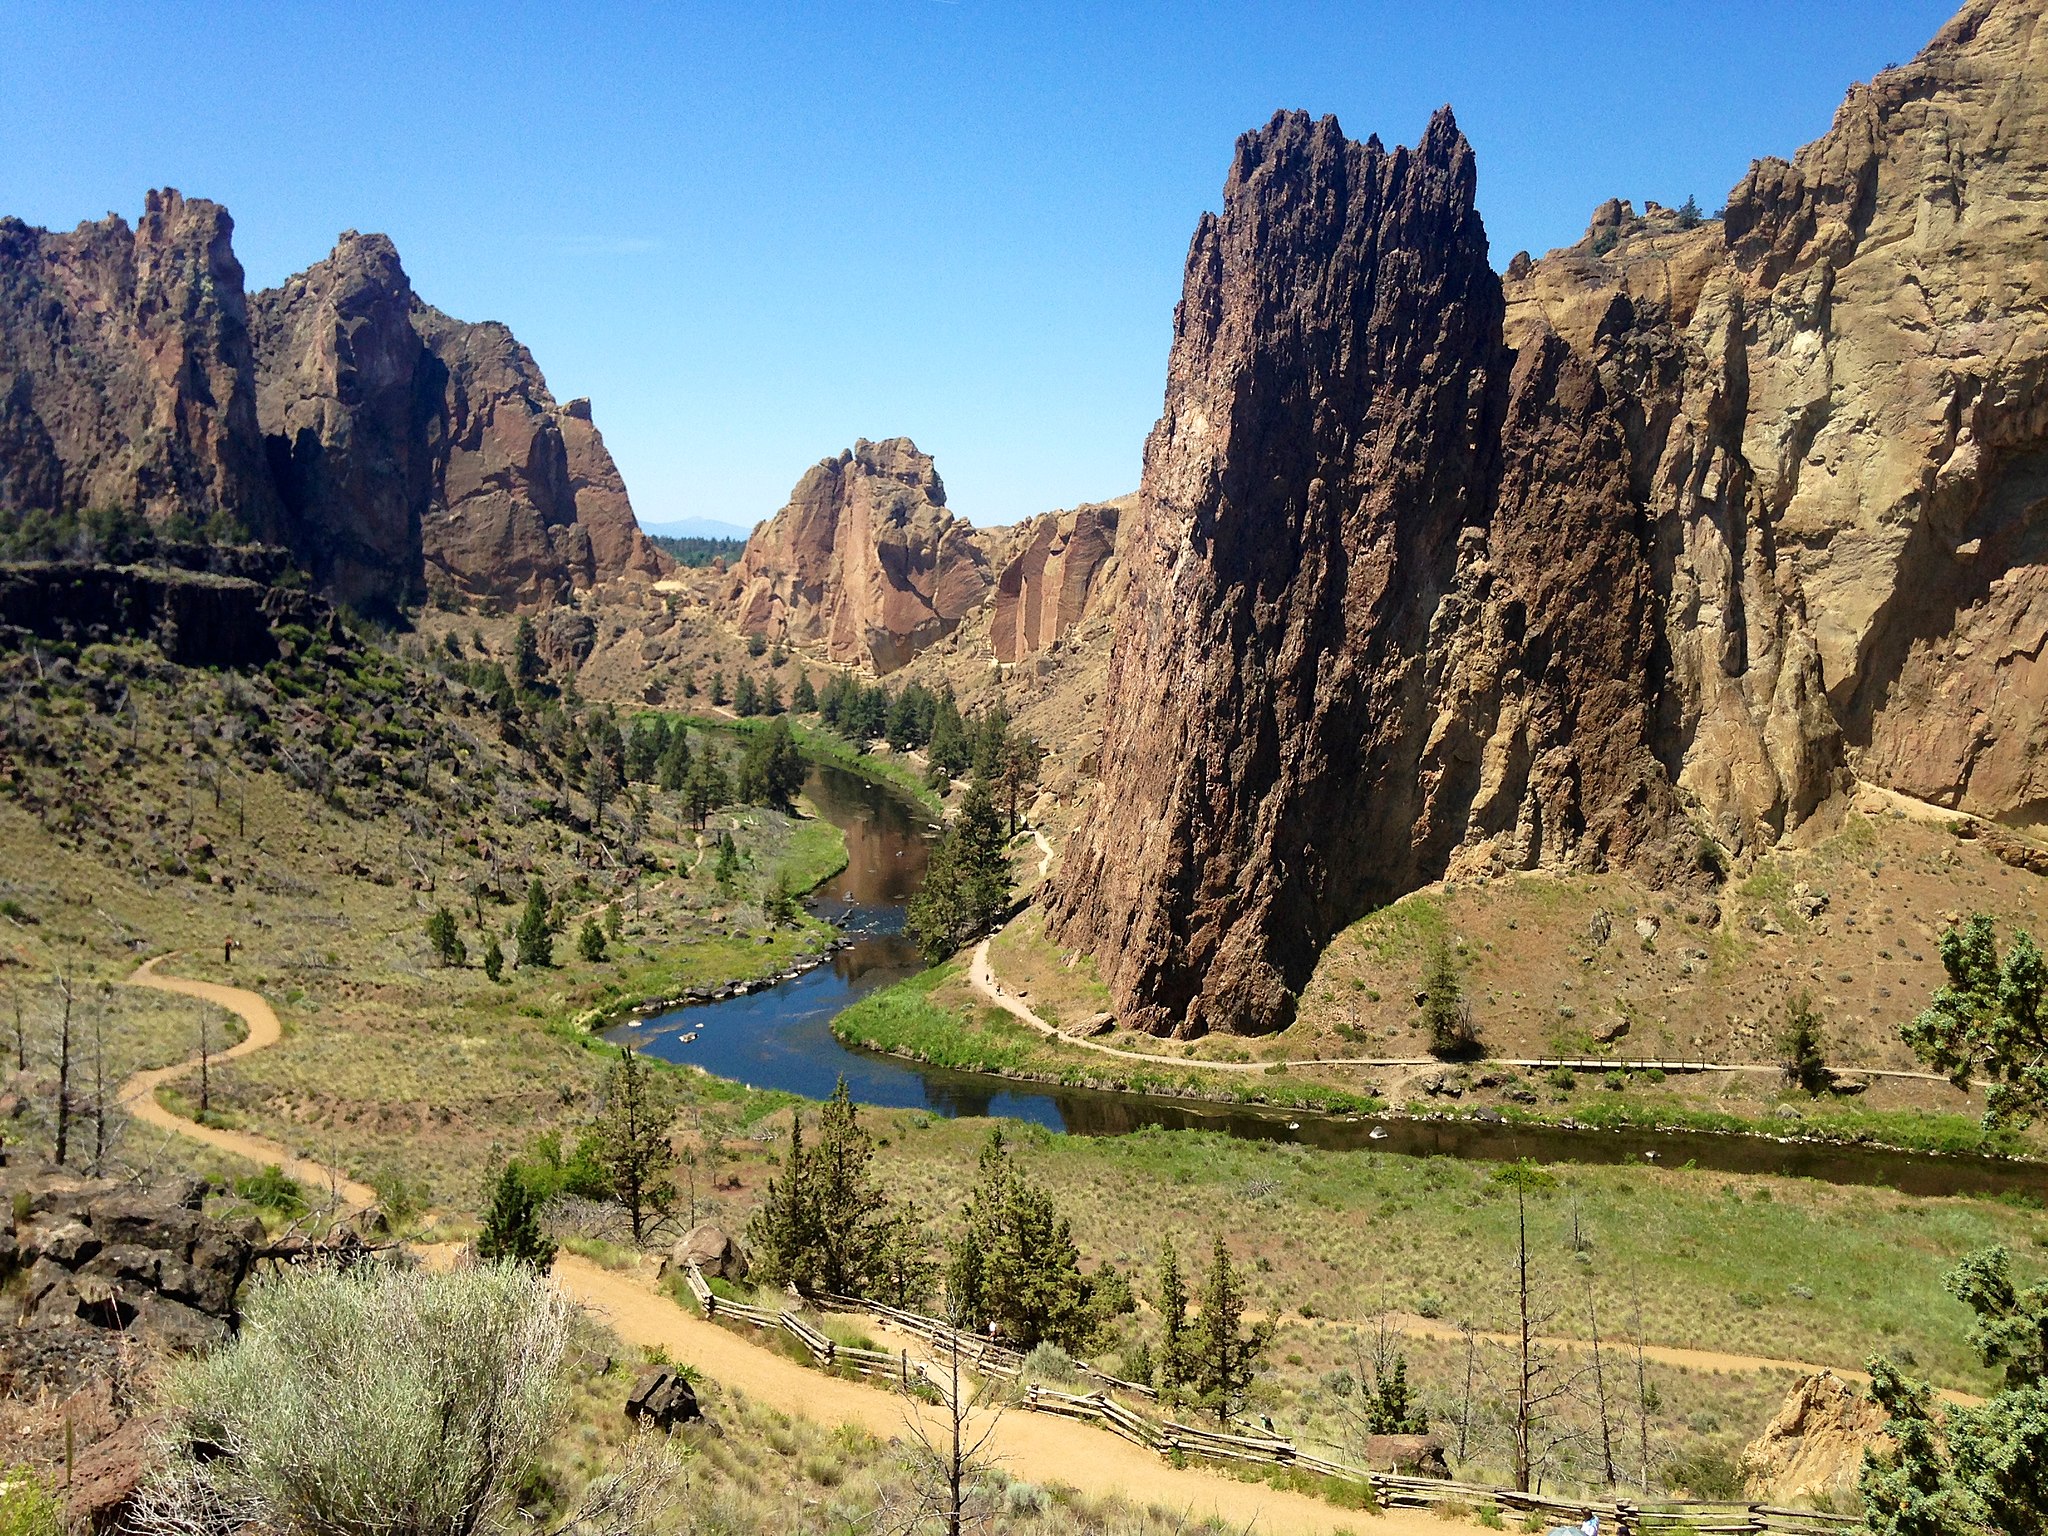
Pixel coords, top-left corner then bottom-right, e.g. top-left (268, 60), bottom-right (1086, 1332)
top-left (0, 0), bottom-right (1952, 522)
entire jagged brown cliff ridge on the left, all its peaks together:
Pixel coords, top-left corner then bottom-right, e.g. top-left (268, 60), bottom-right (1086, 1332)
top-left (0, 190), bottom-right (668, 608)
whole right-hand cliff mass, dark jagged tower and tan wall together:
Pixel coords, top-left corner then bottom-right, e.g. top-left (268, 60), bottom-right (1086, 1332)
top-left (1051, 0), bottom-right (2048, 1034)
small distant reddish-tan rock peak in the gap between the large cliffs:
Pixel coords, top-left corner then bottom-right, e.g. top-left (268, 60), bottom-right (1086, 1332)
top-left (729, 438), bottom-right (989, 674)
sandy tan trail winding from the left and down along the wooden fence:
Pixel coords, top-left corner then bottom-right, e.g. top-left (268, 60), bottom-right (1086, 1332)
top-left (121, 956), bottom-right (1444, 1536)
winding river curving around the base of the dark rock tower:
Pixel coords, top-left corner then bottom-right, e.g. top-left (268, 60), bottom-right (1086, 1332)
top-left (608, 764), bottom-right (2048, 1194)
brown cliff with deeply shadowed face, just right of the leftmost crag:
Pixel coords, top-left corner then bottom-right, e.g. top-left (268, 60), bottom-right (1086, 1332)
top-left (250, 229), bottom-right (666, 604)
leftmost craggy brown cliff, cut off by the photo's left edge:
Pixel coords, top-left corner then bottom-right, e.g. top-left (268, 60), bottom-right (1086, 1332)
top-left (0, 190), bottom-right (281, 537)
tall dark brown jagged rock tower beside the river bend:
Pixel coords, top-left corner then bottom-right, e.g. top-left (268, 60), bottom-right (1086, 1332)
top-left (1053, 113), bottom-right (1509, 1032)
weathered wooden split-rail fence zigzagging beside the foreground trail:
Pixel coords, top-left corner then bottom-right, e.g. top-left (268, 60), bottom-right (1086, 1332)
top-left (684, 1264), bottom-right (1862, 1536)
